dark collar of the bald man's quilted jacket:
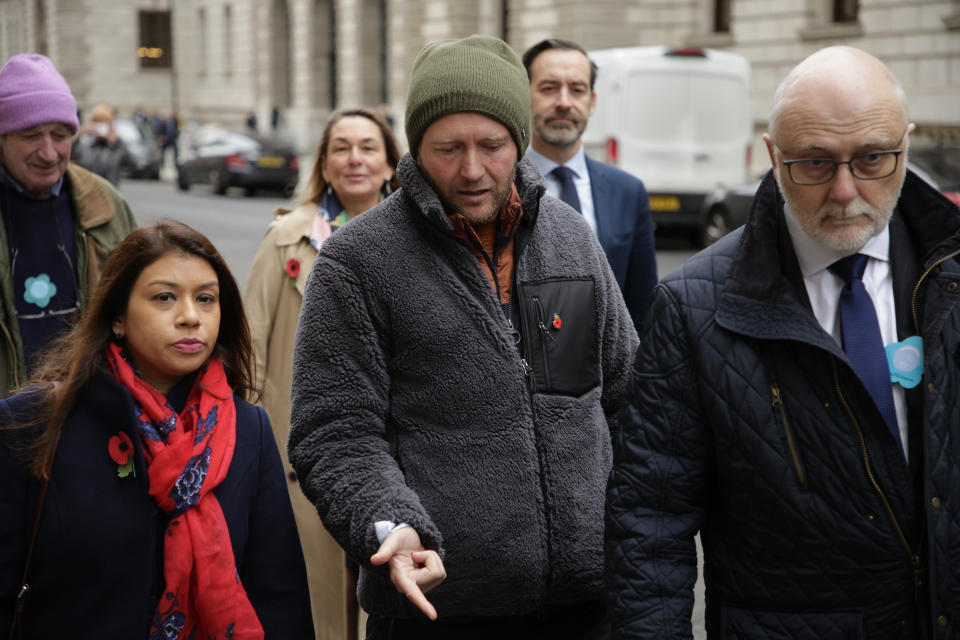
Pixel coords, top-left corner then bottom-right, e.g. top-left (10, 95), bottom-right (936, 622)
top-left (717, 171), bottom-right (960, 344)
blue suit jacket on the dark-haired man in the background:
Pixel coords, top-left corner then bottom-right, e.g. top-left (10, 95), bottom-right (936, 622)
top-left (586, 157), bottom-right (657, 333)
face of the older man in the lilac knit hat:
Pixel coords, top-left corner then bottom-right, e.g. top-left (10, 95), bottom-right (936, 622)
top-left (0, 122), bottom-right (73, 198)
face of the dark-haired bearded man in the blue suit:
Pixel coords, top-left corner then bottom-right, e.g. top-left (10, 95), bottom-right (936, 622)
top-left (530, 49), bottom-right (597, 148)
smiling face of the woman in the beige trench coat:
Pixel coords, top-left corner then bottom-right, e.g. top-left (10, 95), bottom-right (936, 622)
top-left (320, 116), bottom-right (393, 211)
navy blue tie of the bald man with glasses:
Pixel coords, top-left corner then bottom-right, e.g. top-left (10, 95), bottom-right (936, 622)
top-left (830, 253), bottom-right (900, 443)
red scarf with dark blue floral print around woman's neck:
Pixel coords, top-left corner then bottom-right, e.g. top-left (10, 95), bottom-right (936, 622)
top-left (107, 344), bottom-right (264, 640)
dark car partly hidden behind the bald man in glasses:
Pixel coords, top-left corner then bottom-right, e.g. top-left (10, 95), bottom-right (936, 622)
top-left (700, 152), bottom-right (960, 247)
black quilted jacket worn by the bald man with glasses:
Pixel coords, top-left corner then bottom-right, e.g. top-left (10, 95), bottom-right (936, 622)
top-left (607, 173), bottom-right (960, 640)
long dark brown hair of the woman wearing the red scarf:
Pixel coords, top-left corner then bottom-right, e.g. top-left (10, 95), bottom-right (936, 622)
top-left (31, 220), bottom-right (253, 477)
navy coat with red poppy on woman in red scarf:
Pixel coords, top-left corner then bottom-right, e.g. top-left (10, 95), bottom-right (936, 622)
top-left (0, 371), bottom-right (314, 640)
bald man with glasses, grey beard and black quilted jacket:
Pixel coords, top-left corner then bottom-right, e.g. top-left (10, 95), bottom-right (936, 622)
top-left (606, 47), bottom-right (960, 640)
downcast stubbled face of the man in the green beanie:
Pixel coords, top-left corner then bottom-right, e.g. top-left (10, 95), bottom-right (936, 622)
top-left (417, 112), bottom-right (517, 225)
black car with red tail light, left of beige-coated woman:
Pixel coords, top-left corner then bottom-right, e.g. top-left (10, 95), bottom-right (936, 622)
top-left (177, 126), bottom-right (300, 195)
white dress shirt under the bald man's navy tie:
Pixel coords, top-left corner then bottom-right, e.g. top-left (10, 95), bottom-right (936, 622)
top-left (783, 205), bottom-right (908, 455)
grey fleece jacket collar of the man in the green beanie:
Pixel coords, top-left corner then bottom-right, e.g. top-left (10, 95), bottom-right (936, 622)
top-left (397, 153), bottom-right (547, 233)
